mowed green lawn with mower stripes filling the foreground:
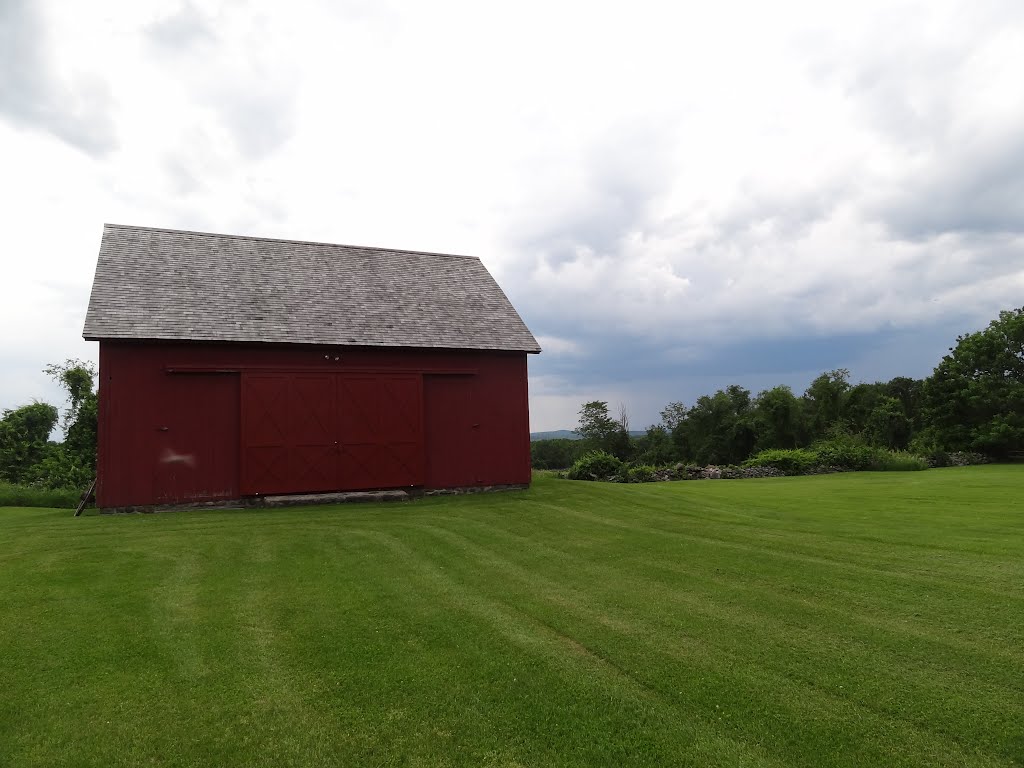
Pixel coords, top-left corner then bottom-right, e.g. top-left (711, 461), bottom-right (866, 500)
top-left (0, 466), bottom-right (1024, 768)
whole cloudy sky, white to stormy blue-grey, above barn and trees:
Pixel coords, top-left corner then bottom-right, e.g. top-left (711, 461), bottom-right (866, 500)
top-left (0, 0), bottom-right (1024, 430)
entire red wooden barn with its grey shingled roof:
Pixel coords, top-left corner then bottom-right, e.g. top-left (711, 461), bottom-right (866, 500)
top-left (84, 224), bottom-right (541, 508)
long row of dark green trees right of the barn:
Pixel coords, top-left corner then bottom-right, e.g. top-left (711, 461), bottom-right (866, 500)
top-left (531, 307), bottom-right (1024, 469)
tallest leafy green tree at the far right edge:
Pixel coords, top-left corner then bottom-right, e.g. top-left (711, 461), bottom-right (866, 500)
top-left (923, 307), bottom-right (1024, 458)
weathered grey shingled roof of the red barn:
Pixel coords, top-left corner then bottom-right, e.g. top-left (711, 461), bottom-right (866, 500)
top-left (84, 224), bottom-right (541, 352)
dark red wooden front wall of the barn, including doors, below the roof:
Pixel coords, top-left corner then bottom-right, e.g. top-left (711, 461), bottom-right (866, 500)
top-left (96, 341), bottom-right (529, 507)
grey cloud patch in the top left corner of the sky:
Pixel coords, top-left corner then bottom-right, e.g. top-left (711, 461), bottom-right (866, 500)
top-left (0, 0), bottom-right (117, 155)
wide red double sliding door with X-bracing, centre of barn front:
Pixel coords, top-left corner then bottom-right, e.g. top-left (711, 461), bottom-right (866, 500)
top-left (242, 373), bottom-right (424, 495)
